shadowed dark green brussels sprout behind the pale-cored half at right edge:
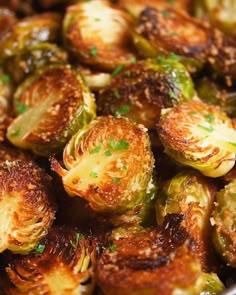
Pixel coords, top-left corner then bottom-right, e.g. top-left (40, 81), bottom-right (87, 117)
top-left (195, 77), bottom-right (236, 117)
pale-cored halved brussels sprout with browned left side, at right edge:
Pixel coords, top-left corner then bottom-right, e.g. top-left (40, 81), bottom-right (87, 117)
top-left (157, 99), bottom-right (236, 177)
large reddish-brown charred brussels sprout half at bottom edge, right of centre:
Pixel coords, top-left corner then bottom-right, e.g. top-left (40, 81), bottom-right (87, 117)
top-left (96, 215), bottom-right (224, 295)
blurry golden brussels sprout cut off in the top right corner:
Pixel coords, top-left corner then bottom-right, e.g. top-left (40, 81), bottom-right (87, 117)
top-left (193, 0), bottom-right (236, 34)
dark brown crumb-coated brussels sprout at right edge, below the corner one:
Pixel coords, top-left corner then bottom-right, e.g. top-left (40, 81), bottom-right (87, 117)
top-left (208, 30), bottom-right (236, 86)
